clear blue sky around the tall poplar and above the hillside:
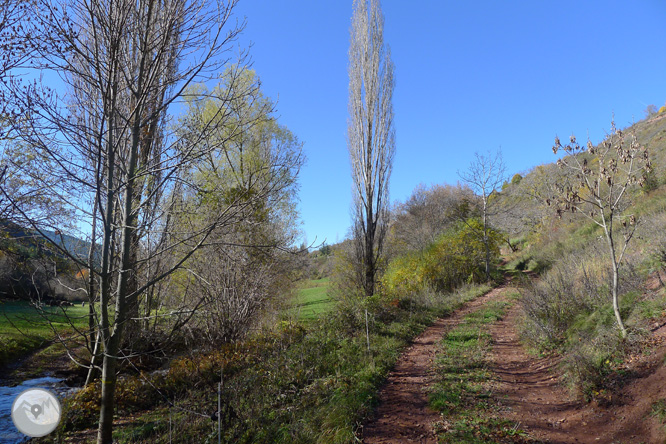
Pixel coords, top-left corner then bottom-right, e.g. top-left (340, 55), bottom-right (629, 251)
top-left (230, 0), bottom-right (666, 243)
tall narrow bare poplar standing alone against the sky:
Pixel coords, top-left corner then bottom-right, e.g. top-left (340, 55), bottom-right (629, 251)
top-left (347, 0), bottom-right (395, 296)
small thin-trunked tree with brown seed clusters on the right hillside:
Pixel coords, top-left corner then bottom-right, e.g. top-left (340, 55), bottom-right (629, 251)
top-left (547, 122), bottom-right (652, 338)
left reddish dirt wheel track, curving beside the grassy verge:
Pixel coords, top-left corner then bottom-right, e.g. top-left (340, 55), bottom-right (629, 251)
top-left (362, 286), bottom-right (506, 444)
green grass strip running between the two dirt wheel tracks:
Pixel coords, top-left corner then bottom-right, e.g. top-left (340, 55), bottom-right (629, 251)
top-left (430, 294), bottom-right (531, 443)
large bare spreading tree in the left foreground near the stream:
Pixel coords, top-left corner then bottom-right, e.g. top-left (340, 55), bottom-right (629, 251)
top-left (4, 0), bottom-right (294, 443)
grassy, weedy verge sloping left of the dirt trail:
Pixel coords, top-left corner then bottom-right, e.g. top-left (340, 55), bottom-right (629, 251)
top-left (60, 286), bottom-right (489, 443)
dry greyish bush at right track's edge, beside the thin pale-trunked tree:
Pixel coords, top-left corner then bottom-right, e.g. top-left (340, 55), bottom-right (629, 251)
top-left (522, 240), bottom-right (642, 402)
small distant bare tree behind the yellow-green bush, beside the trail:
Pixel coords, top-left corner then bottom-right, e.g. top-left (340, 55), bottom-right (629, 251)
top-left (458, 151), bottom-right (506, 279)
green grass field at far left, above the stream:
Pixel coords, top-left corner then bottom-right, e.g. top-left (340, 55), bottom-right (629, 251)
top-left (0, 301), bottom-right (88, 366)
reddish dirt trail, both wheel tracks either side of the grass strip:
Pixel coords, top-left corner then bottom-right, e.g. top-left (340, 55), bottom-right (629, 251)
top-left (362, 280), bottom-right (666, 444)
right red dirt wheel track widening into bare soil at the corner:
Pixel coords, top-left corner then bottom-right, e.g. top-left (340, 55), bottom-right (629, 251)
top-left (491, 304), bottom-right (666, 444)
